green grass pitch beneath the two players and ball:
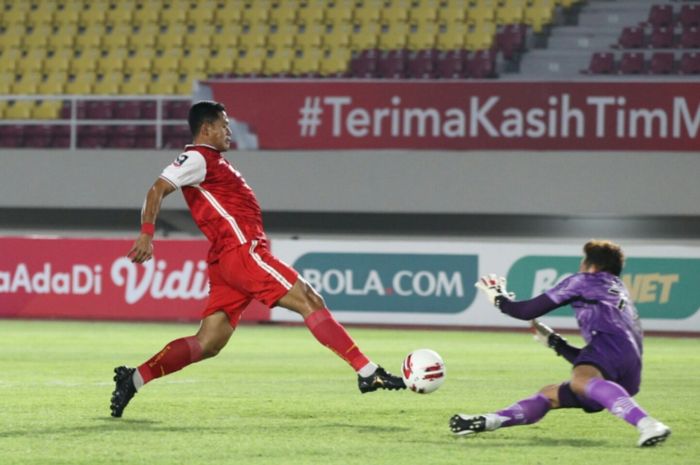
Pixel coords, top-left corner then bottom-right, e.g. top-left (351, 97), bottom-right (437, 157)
top-left (0, 320), bottom-right (700, 465)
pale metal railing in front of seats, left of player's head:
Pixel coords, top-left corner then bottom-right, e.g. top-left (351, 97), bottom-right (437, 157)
top-left (0, 94), bottom-right (189, 150)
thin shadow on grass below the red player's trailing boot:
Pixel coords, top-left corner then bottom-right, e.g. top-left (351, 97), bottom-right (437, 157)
top-left (0, 417), bottom-right (227, 438)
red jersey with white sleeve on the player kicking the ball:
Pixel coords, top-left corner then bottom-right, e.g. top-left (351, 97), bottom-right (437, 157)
top-left (160, 145), bottom-right (265, 263)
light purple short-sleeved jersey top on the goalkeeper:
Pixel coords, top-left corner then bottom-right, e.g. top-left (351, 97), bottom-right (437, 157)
top-left (545, 271), bottom-right (642, 355)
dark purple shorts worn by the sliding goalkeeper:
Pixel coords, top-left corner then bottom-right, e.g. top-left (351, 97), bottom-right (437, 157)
top-left (559, 333), bottom-right (642, 412)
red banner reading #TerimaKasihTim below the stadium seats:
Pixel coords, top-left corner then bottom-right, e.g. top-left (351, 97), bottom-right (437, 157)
top-left (205, 79), bottom-right (700, 151)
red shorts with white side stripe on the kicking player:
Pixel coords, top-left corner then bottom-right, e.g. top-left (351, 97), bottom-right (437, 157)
top-left (202, 241), bottom-right (299, 328)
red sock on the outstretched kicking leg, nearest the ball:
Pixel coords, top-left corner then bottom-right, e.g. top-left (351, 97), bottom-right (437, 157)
top-left (304, 308), bottom-right (369, 371)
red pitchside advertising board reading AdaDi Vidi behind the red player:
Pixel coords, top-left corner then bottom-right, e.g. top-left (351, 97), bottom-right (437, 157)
top-left (0, 237), bottom-right (270, 321)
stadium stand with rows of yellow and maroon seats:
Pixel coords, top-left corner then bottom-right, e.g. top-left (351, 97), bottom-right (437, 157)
top-left (0, 0), bottom-right (700, 148)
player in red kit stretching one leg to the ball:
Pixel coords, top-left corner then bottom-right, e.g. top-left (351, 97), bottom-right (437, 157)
top-left (110, 101), bottom-right (406, 417)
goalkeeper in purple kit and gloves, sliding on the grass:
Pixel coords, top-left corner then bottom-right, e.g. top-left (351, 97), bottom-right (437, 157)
top-left (450, 241), bottom-right (671, 447)
